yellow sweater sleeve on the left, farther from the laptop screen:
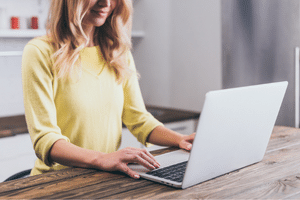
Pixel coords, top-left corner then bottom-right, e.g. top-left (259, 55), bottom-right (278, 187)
top-left (22, 41), bottom-right (69, 166)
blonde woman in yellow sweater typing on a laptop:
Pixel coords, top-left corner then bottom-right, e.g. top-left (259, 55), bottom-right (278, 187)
top-left (22, 0), bottom-right (194, 178)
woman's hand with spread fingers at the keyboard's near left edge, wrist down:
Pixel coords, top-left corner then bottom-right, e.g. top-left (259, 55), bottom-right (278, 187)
top-left (97, 147), bottom-right (160, 179)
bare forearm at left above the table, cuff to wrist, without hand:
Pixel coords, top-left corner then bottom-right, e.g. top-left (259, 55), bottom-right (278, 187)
top-left (50, 140), bottom-right (104, 169)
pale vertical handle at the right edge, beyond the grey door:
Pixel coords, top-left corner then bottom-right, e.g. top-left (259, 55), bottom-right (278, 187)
top-left (295, 47), bottom-right (300, 128)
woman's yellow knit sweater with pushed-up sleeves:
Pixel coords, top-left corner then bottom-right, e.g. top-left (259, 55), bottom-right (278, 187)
top-left (22, 38), bottom-right (162, 175)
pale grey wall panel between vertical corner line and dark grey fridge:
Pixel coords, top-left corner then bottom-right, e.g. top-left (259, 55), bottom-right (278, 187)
top-left (170, 0), bottom-right (222, 111)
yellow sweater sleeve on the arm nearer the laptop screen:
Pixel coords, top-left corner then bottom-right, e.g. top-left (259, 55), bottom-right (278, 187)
top-left (122, 52), bottom-right (163, 146)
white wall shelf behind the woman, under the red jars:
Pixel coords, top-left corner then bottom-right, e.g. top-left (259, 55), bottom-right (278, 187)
top-left (0, 29), bottom-right (145, 38)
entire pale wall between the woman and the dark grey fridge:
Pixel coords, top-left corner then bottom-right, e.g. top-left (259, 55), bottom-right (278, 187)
top-left (134, 0), bottom-right (222, 111)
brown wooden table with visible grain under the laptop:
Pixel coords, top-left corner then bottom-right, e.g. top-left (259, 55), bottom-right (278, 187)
top-left (0, 127), bottom-right (300, 199)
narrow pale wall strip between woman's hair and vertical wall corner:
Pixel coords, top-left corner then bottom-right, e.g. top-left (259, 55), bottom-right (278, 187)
top-left (133, 0), bottom-right (173, 106)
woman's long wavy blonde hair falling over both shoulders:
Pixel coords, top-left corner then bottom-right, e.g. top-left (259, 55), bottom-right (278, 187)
top-left (47, 0), bottom-right (132, 82)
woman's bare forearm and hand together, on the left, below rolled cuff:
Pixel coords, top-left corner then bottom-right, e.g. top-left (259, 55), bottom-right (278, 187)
top-left (49, 140), bottom-right (160, 178)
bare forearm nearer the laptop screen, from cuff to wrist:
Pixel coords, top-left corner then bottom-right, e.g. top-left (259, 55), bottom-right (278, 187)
top-left (147, 126), bottom-right (183, 147)
